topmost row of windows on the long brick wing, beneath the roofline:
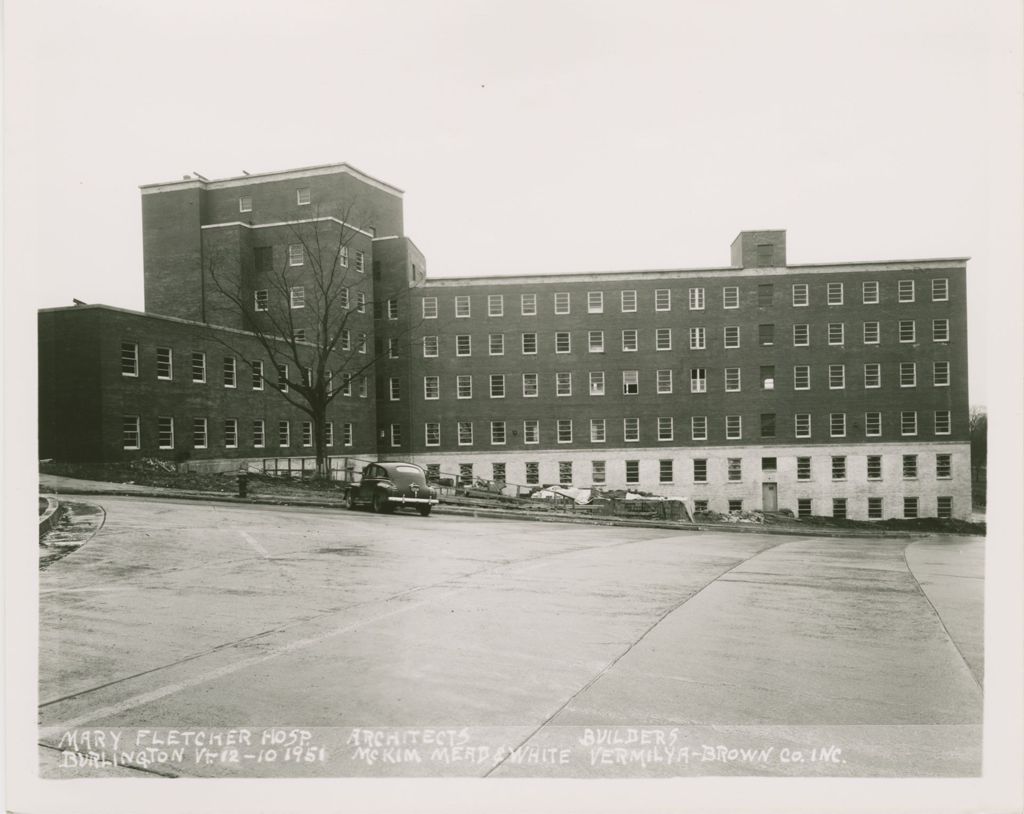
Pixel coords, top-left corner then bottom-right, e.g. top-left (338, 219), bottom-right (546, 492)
top-left (423, 277), bottom-right (949, 319)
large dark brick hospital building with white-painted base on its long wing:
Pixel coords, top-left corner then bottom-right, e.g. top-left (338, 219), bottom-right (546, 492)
top-left (39, 164), bottom-right (971, 519)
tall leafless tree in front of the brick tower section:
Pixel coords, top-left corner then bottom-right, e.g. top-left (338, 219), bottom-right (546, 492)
top-left (207, 206), bottom-right (414, 477)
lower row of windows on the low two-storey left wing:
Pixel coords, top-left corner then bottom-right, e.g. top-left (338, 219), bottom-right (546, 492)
top-left (121, 416), bottom-right (352, 449)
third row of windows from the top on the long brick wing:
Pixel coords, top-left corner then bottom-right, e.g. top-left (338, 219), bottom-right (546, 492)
top-left (397, 361), bottom-right (950, 401)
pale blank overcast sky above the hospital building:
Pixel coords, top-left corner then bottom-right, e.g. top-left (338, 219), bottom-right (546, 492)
top-left (7, 0), bottom-right (1004, 403)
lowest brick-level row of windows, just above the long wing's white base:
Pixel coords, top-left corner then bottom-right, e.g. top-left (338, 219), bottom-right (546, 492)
top-left (390, 410), bottom-right (951, 446)
